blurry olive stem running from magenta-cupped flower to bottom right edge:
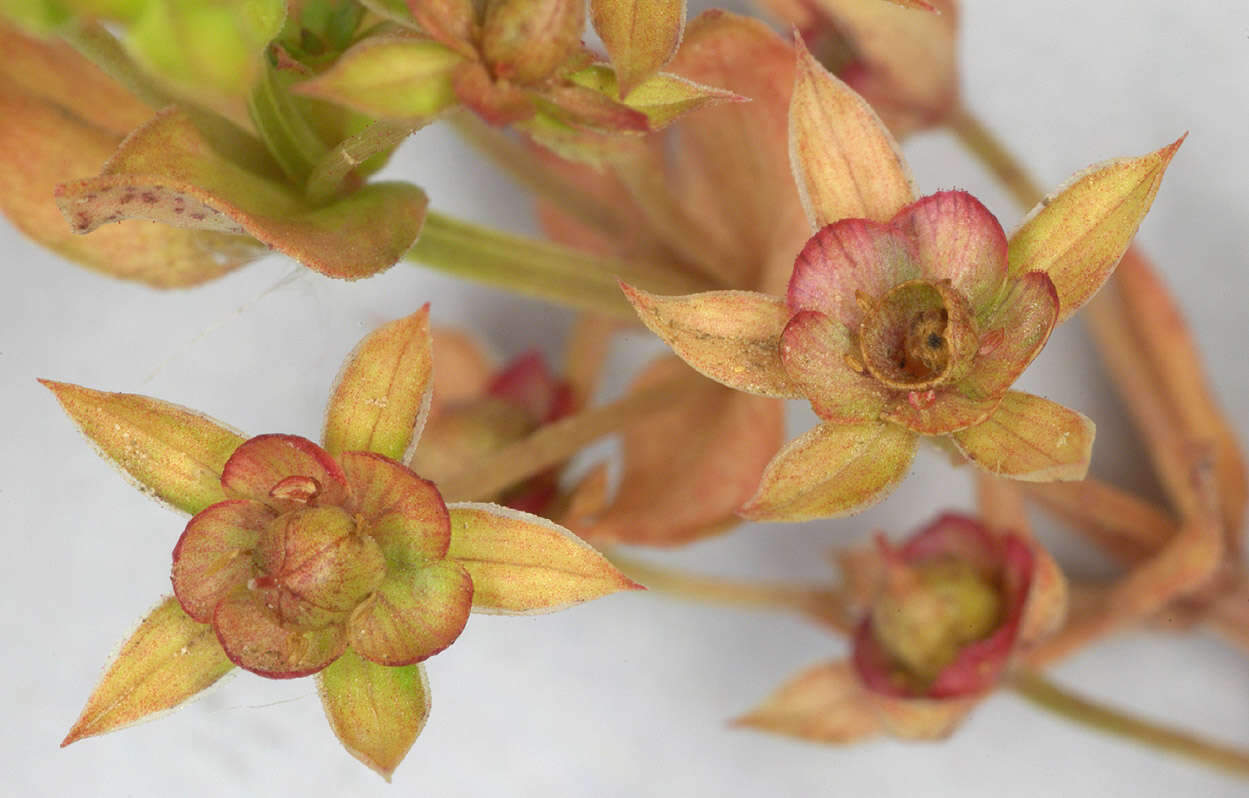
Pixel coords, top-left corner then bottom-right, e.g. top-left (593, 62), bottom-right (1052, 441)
top-left (1010, 673), bottom-right (1249, 778)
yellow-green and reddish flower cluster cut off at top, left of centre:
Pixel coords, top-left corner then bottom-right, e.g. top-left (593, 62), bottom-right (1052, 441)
top-left (297, 0), bottom-right (734, 159)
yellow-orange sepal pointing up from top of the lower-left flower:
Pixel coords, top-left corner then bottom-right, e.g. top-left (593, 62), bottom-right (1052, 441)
top-left (322, 309), bottom-right (433, 462)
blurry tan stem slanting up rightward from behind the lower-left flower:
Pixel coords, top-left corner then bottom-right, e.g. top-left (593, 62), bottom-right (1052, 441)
top-left (438, 373), bottom-right (702, 502)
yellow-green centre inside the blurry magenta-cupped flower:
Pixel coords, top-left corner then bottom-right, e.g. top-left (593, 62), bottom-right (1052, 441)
top-left (872, 559), bottom-right (1002, 688)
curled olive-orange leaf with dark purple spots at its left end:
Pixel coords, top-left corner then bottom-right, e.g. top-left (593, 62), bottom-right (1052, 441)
top-left (55, 107), bottom-right (427, 280)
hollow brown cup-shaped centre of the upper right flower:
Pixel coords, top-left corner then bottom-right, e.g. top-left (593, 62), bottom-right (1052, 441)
top-left (859, 280), bottom-right (979, 391)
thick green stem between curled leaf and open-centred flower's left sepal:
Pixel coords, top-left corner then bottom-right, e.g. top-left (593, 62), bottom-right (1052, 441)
top-left (407, 211), bottom-right (708, 320)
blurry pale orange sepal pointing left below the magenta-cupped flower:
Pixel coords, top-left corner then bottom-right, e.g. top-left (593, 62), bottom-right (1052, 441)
top-left (733, 662), bottom-right (881, 743)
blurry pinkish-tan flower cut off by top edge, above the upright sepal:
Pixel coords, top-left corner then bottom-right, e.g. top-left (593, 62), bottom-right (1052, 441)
top-left (756, 0), bottom-right (959, 139)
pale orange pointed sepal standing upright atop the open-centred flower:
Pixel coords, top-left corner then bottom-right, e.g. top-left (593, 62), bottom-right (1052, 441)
top-left (789, 40), bottom-right (914, 230)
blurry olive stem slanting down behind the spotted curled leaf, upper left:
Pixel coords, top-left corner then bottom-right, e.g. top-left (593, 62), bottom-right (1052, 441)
top-left (61, 22), bottom-right (281, 176)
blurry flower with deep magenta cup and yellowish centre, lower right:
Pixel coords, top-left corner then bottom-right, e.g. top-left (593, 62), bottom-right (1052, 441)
top-left (738, 513), bottom-right (1065, 743)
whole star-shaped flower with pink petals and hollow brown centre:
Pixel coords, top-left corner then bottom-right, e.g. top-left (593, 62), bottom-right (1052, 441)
top-left (625, 37), bottom-right (1183, 521)
